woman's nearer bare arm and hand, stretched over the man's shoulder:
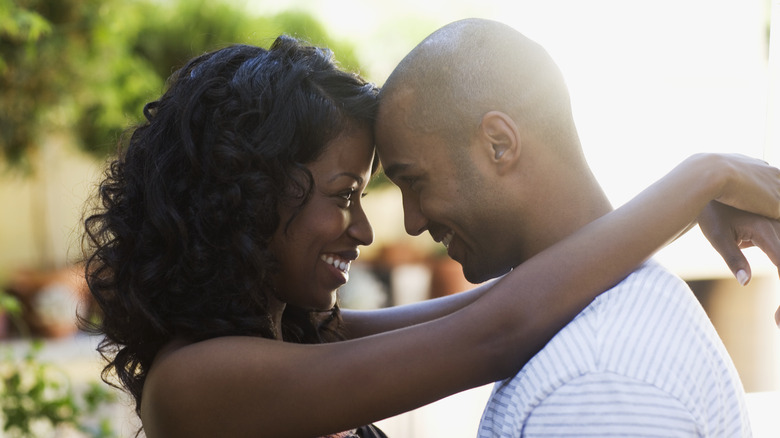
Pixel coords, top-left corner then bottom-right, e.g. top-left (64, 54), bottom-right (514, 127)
top-left (142, 155), bottom-right (780, 438)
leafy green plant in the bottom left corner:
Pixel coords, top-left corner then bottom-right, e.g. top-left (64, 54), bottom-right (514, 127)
top-left (0, 342), bottom-right (118, 438)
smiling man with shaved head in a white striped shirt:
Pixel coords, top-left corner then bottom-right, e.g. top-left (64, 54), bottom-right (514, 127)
top-left (376, 19), bottom-right (750, 437)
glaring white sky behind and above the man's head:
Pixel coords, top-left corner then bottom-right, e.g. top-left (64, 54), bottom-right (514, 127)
top-left (249, 0), bottom-right (780, 275)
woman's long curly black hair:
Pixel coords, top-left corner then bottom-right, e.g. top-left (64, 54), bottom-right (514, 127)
top-left (84, 36), bottom-right (378, 412)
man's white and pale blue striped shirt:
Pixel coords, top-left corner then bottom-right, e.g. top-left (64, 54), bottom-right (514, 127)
top-left (478, 262), bottom-right (751, 438)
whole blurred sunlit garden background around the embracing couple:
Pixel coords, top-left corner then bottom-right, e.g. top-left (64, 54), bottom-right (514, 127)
top-left (0, 0), bottom-right (780, 437)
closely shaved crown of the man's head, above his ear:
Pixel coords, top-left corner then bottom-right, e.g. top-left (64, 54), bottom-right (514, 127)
top-left (380, 19), bottom-right (576, 152)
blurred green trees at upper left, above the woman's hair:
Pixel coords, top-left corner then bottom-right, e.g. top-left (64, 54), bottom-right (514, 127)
top-left (0, 0), bottom-right (366, 168)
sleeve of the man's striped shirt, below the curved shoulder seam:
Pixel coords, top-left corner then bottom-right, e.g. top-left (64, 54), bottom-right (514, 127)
top-left (521, 373), bottom-right (701, 438)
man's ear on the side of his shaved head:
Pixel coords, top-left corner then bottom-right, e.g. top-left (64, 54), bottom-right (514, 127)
top-left (480, 111), bottom-right (521, 171)
